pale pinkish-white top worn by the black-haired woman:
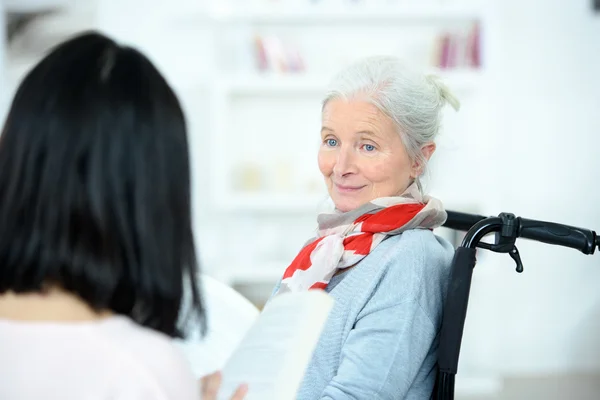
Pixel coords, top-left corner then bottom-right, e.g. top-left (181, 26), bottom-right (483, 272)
top-left (0, 316), bottom-right (200, 400)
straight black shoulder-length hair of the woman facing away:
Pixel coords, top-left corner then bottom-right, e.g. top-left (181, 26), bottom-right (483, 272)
top-left (0, 33), bottom-right (203, 336)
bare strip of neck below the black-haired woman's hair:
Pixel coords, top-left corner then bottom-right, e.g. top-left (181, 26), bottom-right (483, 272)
top-left (0, 288), bottom-right (112, 322)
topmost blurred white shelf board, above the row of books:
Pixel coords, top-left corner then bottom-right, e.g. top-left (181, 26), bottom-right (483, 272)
top-left (209, 4), bottom-right (482, 25)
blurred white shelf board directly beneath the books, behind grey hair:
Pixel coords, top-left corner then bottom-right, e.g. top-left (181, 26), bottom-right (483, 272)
top-left (215, 70), bottom-right (482, 96)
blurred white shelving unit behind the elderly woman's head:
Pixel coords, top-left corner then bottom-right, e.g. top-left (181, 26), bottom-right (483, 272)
top-left (203, 0), bottom-right (485, 214)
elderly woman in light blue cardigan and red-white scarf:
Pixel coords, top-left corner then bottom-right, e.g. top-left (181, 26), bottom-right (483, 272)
top-left (274, 57), bottom-right (459, 400)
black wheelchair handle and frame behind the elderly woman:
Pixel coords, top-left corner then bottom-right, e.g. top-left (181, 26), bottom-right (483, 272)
top-left (431, 211), bottom-right (600, 400)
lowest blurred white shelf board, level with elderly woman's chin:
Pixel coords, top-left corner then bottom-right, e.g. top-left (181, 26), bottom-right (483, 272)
top-left (215, 193), bottom-right (328, 213)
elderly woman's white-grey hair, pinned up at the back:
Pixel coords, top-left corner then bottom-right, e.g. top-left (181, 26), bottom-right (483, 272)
top-left (323, 56), bottom-right (460, 190)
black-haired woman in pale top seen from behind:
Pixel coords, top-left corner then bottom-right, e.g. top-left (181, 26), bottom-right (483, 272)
top-left (0, 32), bottom-right (243, 400)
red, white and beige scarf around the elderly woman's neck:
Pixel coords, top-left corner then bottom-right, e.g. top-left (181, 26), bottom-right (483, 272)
top-left (277, 184), bottom-right (447, 294)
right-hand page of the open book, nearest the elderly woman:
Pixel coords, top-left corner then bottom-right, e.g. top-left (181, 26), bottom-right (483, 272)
top-left (219, 290), bottom-right (333, 400)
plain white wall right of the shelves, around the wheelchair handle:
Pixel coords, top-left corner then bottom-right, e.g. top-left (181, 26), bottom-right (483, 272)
top-left (465, 0), bottom-right (600, 374)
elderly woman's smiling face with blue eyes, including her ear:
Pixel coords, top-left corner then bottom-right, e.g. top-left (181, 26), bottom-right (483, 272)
top-left (319, 100), bottom-right (435, 212)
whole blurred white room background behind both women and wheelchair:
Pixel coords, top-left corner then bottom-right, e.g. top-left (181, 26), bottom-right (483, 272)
top-left (0, 0), bottom-right (600, 400)
